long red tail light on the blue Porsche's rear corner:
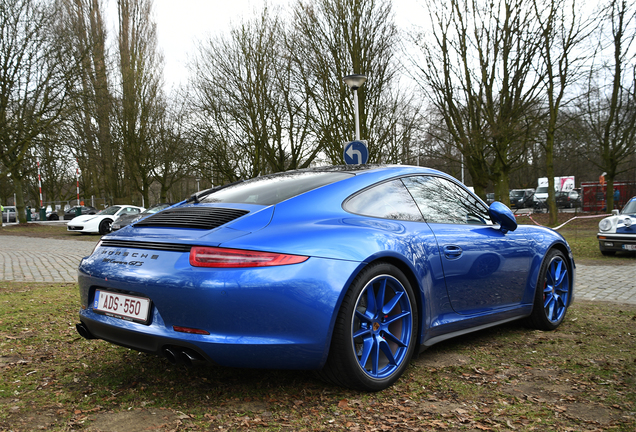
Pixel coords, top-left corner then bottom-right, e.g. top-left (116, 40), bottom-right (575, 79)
top-left (190, 246), bottom-right (309, 268)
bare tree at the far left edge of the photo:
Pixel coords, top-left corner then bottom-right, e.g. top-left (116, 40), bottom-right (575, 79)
top-left (0, 0), bottom-right (75, 222)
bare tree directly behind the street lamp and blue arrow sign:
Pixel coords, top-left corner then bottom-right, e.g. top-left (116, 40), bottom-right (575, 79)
top-left (289, 0), bottom-right (421, 164)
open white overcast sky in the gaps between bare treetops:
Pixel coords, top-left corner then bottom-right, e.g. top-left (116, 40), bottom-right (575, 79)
top-left (144, 0), bottom-right (425, 91)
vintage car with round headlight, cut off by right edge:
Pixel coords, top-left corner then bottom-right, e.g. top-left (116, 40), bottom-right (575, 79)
top-left (596, 196), bottom-right (636, 255)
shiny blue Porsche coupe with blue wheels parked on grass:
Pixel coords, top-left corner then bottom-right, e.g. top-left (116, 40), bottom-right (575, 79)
top-left (77, 166), bottom-right (575, 391)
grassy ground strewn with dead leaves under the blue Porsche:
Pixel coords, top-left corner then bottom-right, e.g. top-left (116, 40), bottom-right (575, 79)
top-left (0, 282), bottom-right (636, 431)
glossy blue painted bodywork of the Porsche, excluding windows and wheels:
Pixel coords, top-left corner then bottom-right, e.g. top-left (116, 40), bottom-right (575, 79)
top-left (78, 167), bottom-right (574, 369)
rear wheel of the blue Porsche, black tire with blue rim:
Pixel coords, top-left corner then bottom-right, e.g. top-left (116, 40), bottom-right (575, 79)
top-left (319, 263), bottom-right (419, 391)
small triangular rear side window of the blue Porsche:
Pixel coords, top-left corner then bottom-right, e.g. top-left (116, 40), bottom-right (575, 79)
top-left (344, 180), bottom-right (423, 222)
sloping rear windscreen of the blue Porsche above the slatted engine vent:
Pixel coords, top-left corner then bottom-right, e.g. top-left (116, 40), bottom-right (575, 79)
top-left (201, 171), bottom-right (354, 205)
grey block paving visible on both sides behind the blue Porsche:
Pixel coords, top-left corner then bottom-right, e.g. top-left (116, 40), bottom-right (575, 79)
top-left (0, 236), bottom-right (636, 304)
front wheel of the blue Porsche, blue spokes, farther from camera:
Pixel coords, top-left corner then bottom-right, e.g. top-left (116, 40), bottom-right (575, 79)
top-left (529, 249), bottom-right (572, 330)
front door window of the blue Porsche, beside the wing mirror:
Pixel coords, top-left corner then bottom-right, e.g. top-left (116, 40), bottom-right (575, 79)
top-left (402, 176), bottom-right (492, 225)
